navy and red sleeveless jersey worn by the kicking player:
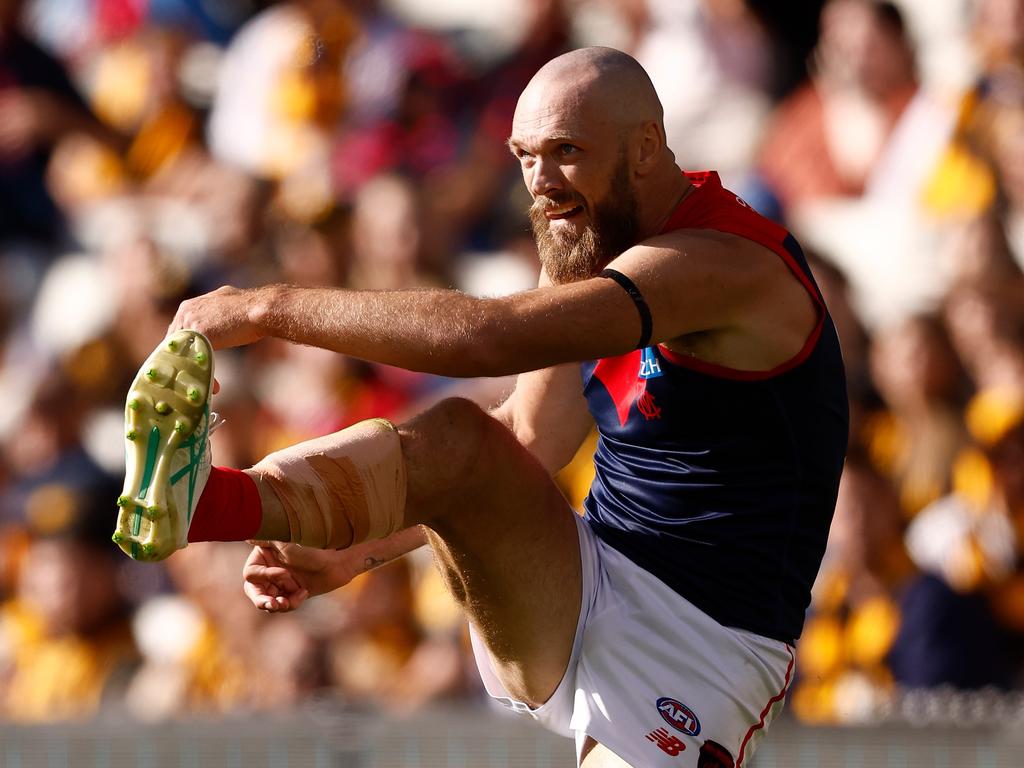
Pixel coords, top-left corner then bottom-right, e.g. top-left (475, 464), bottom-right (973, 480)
top-left (582, 172), bottom-right (849, 642)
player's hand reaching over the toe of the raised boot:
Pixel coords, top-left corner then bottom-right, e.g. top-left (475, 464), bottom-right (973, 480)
top-left (168, 286), bottom-right (262, 349)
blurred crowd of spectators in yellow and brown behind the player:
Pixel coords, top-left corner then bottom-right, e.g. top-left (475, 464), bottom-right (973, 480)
top-left (0, 0), bottom-right (1024, 723)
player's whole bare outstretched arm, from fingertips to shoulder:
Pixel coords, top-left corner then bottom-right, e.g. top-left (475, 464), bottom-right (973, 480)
top-left (172, 231), bottom-right (811, 377)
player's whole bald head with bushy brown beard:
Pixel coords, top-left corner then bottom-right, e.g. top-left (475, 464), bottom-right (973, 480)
top-left (509, 48), bottom-right (685, 283)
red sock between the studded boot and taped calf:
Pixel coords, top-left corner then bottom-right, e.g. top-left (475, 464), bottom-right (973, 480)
top-left (188, 467), bottom-right (263, 542)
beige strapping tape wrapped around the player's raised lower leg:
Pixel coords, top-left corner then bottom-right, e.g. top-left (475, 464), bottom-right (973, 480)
top-left (253, 419), bottom-right (406, 549)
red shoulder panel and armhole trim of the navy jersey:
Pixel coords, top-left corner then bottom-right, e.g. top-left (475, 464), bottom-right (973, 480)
top-left (658, 171), bottom-right (825, 381)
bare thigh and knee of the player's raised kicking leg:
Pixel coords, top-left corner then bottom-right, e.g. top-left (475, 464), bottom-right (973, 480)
top-left (399, 400), bottom-right (583, 707)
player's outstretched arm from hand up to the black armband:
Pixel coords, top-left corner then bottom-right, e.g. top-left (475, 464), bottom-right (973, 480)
top-left (172, 280), bottom-right (639, 377)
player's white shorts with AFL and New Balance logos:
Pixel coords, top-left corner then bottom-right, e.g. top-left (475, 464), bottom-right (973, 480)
top-left (472, 518), bottom-right (794, 768)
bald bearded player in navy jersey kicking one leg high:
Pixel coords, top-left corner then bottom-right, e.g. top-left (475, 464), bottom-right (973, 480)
top-left (115, 48), bottom-right (847, 768)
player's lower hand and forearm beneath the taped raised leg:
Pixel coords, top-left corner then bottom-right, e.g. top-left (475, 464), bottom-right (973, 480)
top-left (242, 525), bottom-right (427, 613)
